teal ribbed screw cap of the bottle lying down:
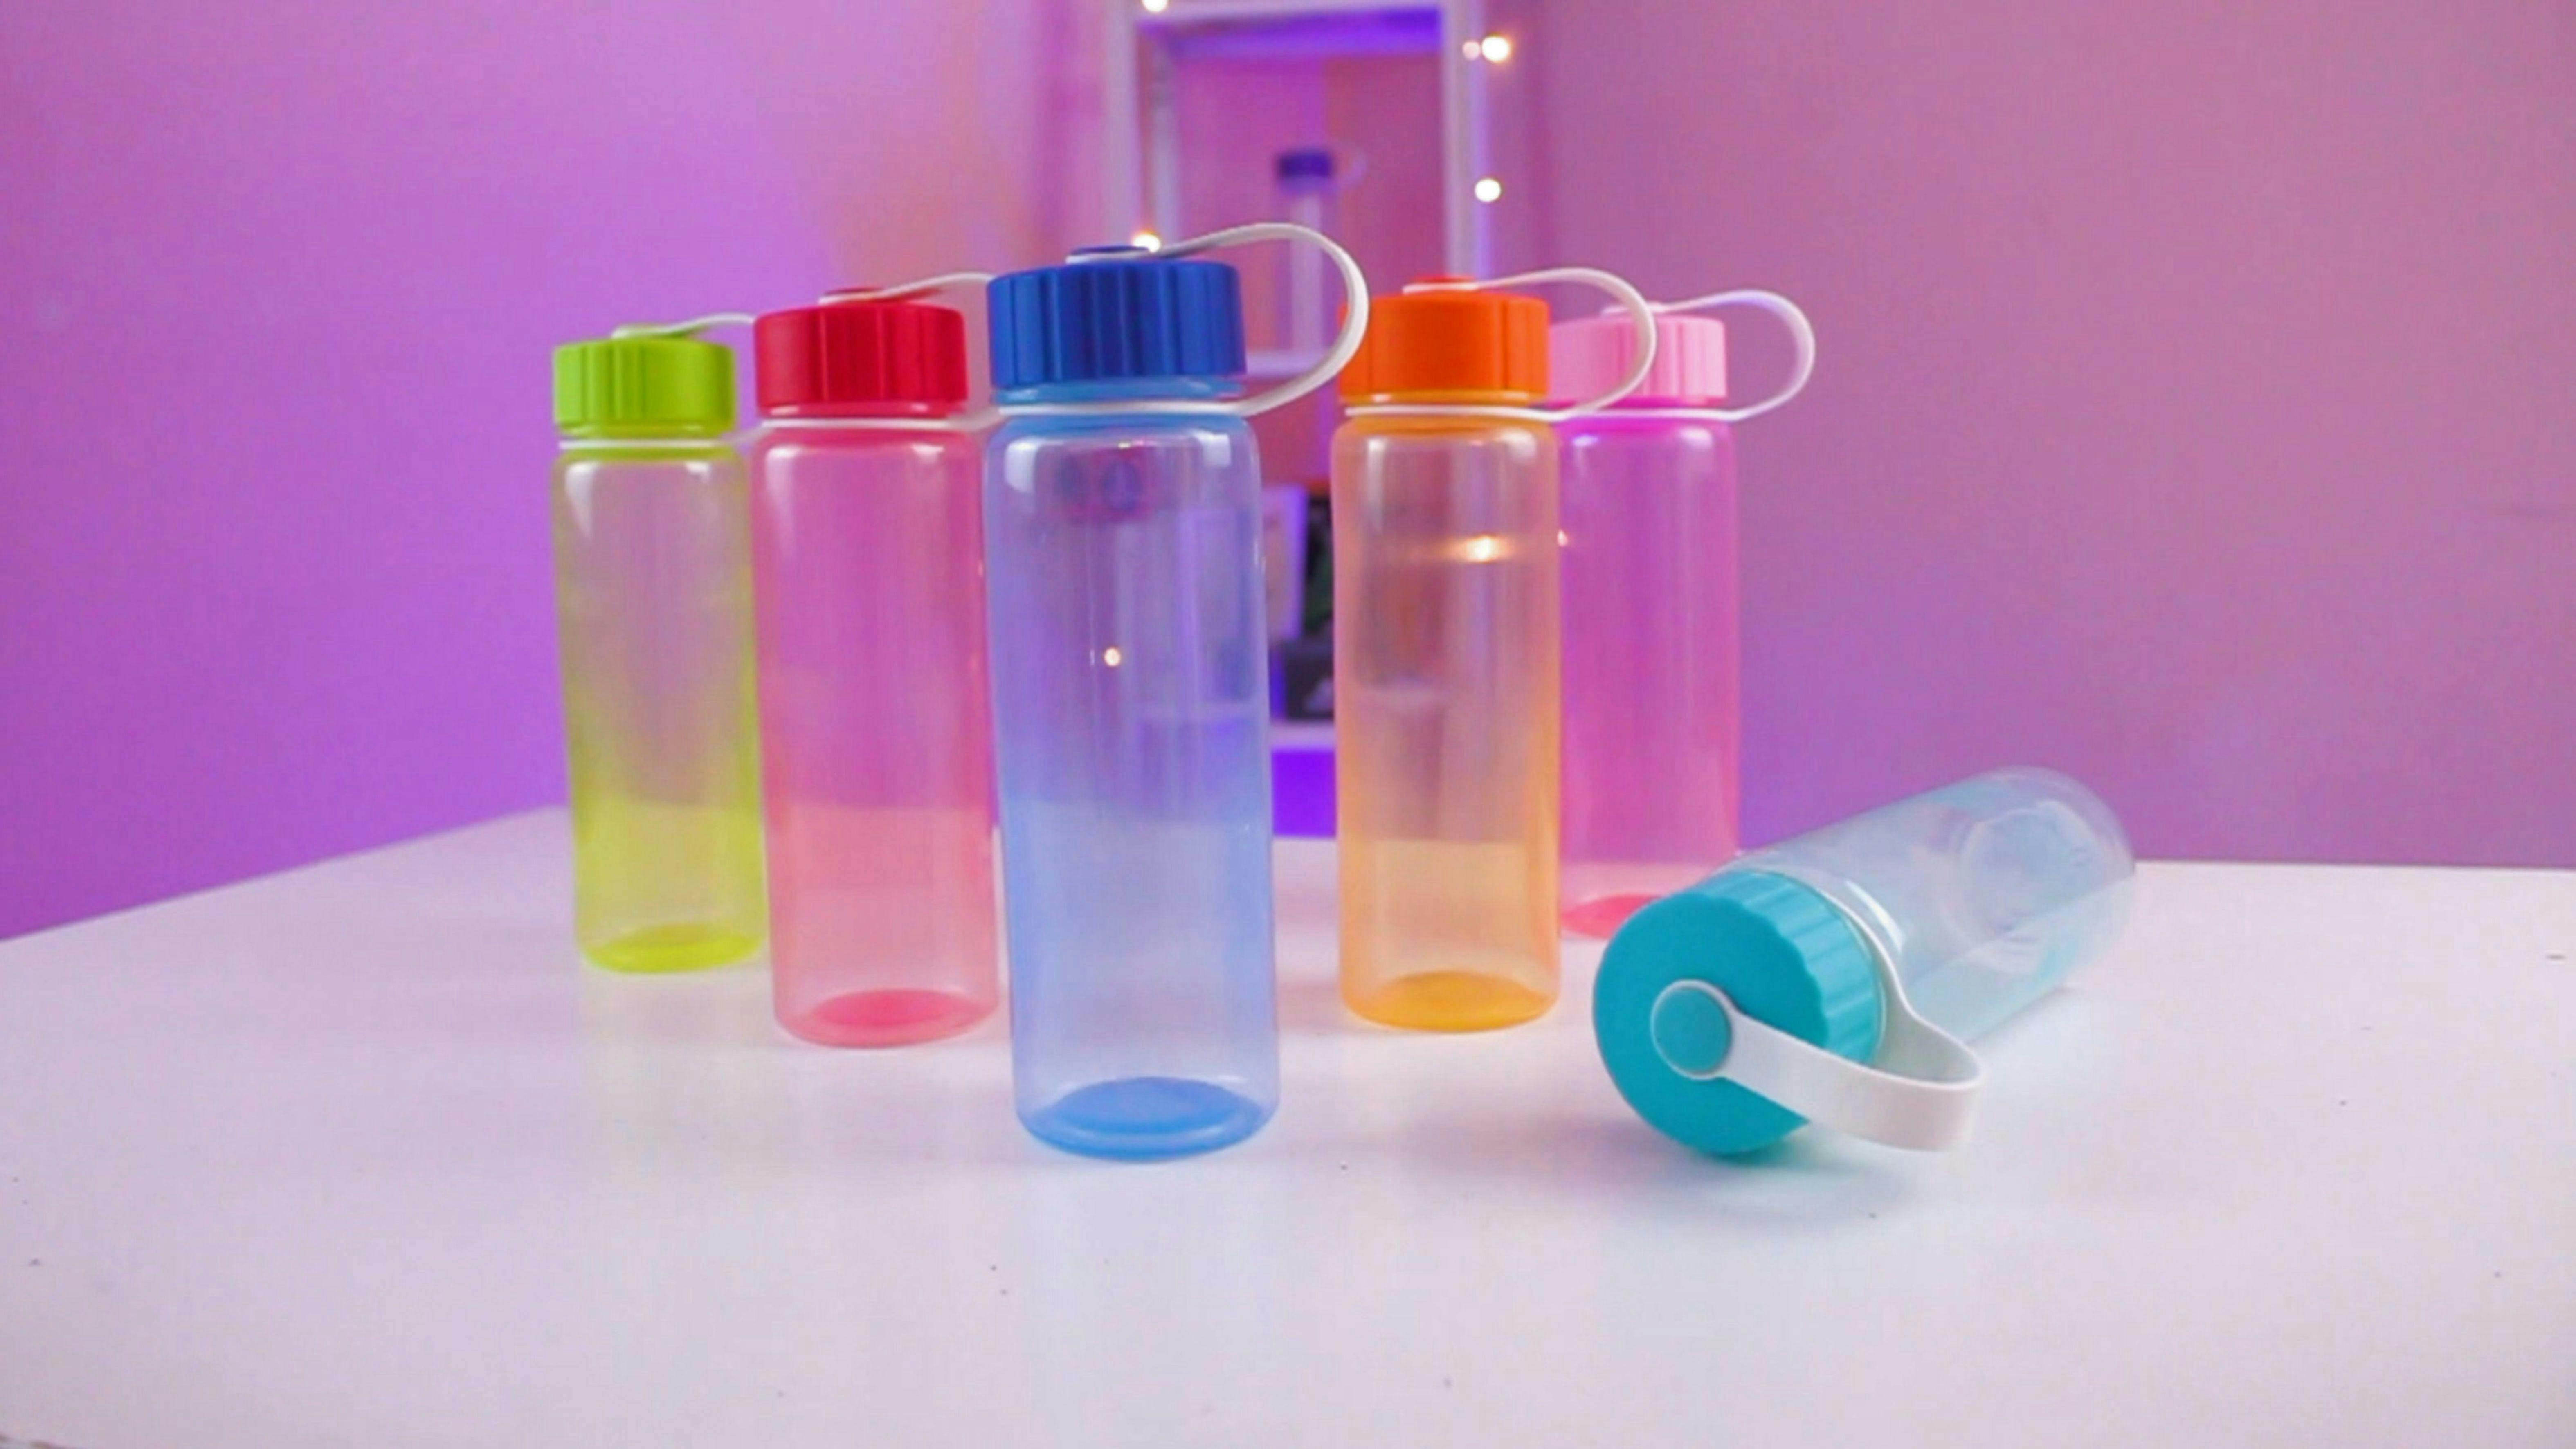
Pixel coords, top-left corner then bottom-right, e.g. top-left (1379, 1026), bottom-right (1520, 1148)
top-left (1592, 870), bottom-right (1886, 1156)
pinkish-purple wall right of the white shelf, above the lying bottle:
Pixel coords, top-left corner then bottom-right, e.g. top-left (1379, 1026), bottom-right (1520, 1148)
top-left (1507, 0), bottom-right (2576, 865)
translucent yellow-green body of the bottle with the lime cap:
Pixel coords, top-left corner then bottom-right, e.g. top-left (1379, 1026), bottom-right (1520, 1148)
top-left (554, 440), bottom-right (765, 970)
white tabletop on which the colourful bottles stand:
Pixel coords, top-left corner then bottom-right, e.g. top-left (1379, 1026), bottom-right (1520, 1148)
top-left (0, 813), bottom-right (2576, 1449)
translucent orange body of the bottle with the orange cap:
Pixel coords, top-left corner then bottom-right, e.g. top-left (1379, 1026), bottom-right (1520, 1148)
top-left (1332, 414), bottom-right (1561, 1032)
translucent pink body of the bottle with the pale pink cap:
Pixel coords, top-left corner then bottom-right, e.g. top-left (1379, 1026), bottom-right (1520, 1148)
top-left (1558, 409), bottom-right (1741, 937)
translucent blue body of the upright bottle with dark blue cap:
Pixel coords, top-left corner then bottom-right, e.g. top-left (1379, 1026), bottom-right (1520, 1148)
top-left (984, 386), bottom-right (1278, 1158)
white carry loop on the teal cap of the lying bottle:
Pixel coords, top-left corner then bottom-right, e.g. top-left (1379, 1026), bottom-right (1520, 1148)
top-left (1654, 963), bottom-right (1986, 1153)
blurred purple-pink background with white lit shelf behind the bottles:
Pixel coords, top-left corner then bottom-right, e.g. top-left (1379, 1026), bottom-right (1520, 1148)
top-left (0, 0), bottom-right (2576, 934)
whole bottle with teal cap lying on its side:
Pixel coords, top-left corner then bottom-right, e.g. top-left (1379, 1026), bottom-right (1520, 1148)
top-left (1592, 770), bottom-right (2135, 1153)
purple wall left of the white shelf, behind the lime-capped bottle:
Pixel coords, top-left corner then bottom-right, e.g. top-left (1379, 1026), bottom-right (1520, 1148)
top-left (0, 0), bottom-right (1048, 934)
